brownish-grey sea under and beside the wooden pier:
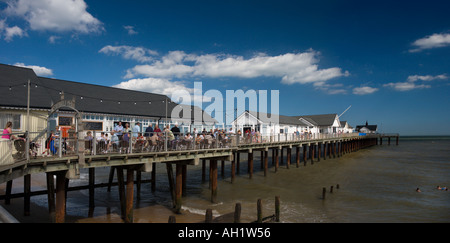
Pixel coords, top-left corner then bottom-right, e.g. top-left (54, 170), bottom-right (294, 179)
top-left (0, 136), bottom-right (450, 223)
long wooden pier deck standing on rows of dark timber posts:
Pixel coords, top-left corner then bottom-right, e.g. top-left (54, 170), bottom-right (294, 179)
top-left (0, 134), bottom-right (398, 223)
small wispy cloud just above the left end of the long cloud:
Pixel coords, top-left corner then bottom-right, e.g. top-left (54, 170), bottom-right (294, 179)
top-left (99, 45), bottom-right (158, 62)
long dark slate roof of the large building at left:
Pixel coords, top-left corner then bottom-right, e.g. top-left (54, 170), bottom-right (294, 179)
top-left (0, 64), bottom-right (215, 121)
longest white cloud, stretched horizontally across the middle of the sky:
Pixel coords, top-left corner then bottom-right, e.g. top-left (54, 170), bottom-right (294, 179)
top-left (121, 50), bottom-right (349, 84)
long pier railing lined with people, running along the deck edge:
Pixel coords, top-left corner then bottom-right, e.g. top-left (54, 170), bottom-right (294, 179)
top-left (0, 131), bottom-right (368, 167)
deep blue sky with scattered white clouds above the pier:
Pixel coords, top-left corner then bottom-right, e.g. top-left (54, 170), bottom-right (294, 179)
top-left (0, 0), bottom-right (450, 135)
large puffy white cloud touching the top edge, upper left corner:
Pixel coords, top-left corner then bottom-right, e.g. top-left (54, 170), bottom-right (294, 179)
top-left (4, 0), bottom-right (104, 34)
